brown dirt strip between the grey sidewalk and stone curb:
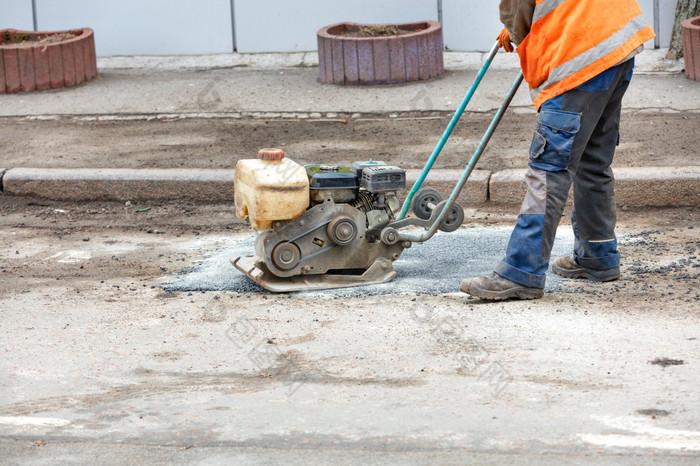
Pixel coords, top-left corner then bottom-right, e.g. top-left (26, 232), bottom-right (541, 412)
top-left (0, 112), bottom-right (700, 171)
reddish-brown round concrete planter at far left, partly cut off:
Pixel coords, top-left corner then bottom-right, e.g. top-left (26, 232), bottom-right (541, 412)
top-left (0, 28), bottom-right (97, 94)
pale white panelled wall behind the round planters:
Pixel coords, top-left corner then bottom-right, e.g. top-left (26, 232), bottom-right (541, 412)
top-left (0, 0), bottom-right (677, 56)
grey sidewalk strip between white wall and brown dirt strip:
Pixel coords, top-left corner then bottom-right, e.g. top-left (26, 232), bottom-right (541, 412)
top-left (0, 51), bottom-right (700, 118)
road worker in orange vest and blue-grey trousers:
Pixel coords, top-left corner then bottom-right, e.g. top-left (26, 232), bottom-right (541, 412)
top-left (460, 0), bottom-right (654, 300)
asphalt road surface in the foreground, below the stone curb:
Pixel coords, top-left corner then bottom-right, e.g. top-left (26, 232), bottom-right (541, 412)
top-left (0, 196), bottom-right (700, 464)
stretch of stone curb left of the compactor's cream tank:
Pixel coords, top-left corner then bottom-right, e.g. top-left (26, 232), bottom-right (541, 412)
top-left (2, 168), bottom-right (233, 202)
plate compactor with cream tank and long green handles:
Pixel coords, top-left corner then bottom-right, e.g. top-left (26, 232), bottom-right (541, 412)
top-left (231, 44), bottom-right (522, 292)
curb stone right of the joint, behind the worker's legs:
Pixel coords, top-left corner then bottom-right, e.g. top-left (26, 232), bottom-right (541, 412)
top-left (489, 166), bottom-right (700, 208)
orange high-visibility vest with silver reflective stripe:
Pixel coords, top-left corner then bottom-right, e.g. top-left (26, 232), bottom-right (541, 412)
top-left (517, 0), bottom-right (654, 110)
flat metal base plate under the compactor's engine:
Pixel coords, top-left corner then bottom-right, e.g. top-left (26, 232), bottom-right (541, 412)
top-left (231, 256), bottom-right (396, 293)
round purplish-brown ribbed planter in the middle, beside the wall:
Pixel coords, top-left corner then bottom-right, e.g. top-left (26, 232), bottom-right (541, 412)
top-left (317, 21), bottom-right (445, 85)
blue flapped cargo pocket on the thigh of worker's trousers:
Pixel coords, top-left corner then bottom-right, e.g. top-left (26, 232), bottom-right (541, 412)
top-left (530, 109), bottom-right (581, 171)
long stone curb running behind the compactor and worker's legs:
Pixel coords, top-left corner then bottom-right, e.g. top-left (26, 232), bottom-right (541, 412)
top-left (0, 166), bottom-right (700, 208)
